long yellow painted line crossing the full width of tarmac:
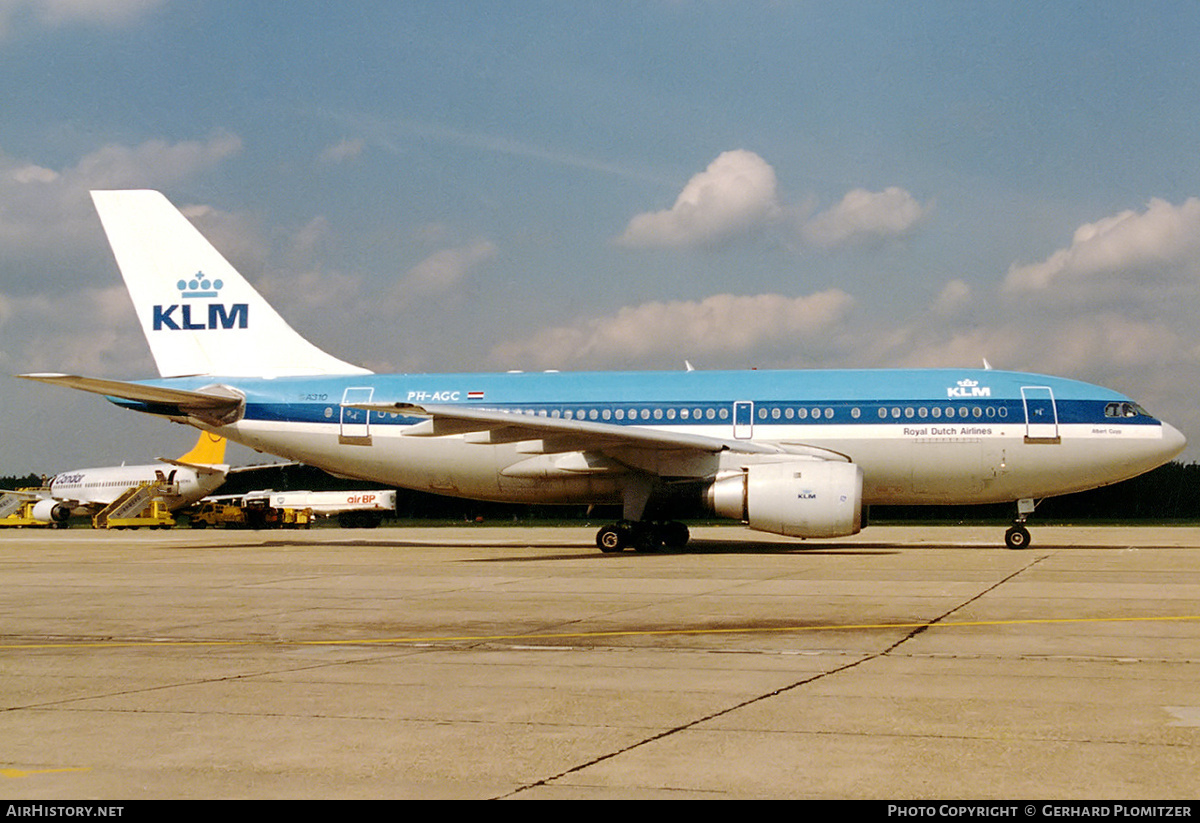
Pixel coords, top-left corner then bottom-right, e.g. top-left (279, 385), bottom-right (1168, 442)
top-left (0, 614), bottom-right (1200, 651)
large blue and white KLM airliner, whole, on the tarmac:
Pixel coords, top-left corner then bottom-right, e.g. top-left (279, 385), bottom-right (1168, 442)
top-left (23, 191), bottom-right (1184, 552)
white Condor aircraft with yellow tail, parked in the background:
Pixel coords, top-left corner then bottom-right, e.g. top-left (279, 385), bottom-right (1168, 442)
top-left (4, 432), bottom-right (229, 523)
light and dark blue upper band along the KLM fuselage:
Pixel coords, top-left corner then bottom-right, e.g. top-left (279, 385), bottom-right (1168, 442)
top-left (129, 370), bottom-right (1158, 426)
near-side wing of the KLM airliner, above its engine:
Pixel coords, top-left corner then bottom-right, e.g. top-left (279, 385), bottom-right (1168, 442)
top-left (353, 403), bottom-right (848, 461)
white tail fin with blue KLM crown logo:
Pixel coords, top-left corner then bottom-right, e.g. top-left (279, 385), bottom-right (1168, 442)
top-left (91, 191), bottom-right (367, 377)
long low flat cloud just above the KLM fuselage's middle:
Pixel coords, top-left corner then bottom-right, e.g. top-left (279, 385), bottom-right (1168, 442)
top-left (492, 289), bottom-right (854, 368)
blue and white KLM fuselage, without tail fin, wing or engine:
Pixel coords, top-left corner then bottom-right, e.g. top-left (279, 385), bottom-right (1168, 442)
top-left (105, 370), bottom-right (1183, 504)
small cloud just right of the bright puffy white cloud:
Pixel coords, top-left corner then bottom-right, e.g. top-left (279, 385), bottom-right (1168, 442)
top-left (800, 186), bottom-right (929, 248)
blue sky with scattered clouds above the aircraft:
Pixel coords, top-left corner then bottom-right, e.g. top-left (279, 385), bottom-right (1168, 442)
top-left (0, 0), bottom-right (1200, 474)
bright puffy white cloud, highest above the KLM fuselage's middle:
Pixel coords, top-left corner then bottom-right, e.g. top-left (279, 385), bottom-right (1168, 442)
top-left (617, 150), bottom-right (779, 248)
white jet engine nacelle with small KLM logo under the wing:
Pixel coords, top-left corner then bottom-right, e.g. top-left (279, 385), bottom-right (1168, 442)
top-left (707, 459), bottom-right (863, 537)
